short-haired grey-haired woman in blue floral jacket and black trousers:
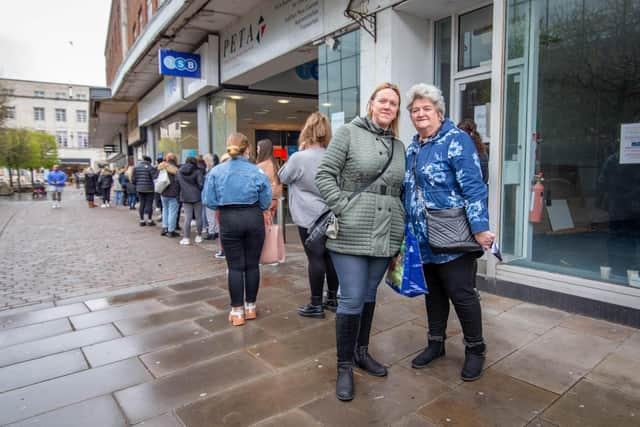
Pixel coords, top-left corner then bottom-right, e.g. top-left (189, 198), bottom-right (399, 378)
top-left (403, 83), bottom-right (495, 381)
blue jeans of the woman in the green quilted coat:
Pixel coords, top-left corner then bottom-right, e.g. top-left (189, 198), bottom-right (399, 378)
top-left (329, 251), bottom-right (391, 314)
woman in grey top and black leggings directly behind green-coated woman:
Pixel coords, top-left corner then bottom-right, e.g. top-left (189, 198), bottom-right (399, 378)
top-left (278, 112), bottom-right (338, 318)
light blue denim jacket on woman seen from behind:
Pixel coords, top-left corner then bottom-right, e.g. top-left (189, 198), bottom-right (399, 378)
top-left (202, 157), bottom-right (271, 210)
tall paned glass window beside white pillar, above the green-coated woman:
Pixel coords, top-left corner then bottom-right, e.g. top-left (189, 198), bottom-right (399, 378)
top-left (318, 30), bottom-right (360, 123)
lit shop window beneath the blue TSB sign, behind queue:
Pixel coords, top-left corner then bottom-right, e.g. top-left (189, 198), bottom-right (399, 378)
top-left (156, 113), bottom-right (199, 164)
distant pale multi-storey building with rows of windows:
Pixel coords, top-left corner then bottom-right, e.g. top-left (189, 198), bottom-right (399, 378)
top-left (0, 79), bottom-right (105, 171)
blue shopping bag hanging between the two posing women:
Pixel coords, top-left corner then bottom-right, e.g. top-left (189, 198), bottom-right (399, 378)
top-left (385, 224), bottom-right (429, 297)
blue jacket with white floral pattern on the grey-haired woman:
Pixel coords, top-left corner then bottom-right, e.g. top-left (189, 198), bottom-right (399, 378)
top-left (403, 119), bottom-right (489, 264)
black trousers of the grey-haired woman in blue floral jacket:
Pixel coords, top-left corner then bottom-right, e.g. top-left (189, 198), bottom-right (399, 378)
top-left (424, 254), bottom-right (483, 343)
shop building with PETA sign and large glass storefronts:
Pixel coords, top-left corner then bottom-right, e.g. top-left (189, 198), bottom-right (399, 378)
top-left (96, 0), bottom-right (640, 326)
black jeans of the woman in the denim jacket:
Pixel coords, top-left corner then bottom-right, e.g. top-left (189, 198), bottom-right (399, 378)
top-left (218, 206), bottom-right (264, 307)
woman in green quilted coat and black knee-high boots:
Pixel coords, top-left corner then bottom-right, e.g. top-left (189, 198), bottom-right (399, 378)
top-left (316, 83), bottom-right (405, 400)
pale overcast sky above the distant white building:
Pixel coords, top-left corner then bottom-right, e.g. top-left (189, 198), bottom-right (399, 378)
top-left (0, 0), bottom-right (111, 86)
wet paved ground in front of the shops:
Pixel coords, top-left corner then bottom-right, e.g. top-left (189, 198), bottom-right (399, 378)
top-left (0, 192), bottom-right (640, 427)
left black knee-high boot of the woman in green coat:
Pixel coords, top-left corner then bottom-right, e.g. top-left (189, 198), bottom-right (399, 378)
top-left (336, 313), bottom-right (360, 401)
